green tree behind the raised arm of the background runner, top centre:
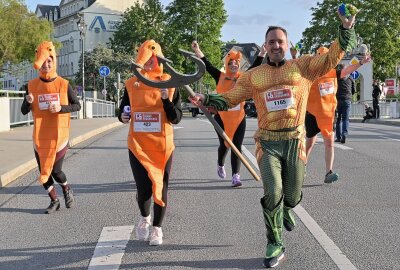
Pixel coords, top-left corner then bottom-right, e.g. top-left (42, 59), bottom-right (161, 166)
top-left (165, 0), bottom-right (227, 100)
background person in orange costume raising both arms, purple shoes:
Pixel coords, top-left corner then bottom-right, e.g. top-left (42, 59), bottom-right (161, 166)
top-left (192, 40), bottom-right (266, 187)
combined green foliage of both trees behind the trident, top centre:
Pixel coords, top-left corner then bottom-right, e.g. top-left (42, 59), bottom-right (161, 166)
top-left (111, 0), bottom-right (227, 99)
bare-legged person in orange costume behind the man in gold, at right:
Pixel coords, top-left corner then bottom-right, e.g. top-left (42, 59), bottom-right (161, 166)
top-left (290, 46), bottom-right (371, 183)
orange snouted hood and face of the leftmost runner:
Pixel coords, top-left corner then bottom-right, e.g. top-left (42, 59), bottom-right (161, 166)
top-left (33, 41), bottom-right (57, 80)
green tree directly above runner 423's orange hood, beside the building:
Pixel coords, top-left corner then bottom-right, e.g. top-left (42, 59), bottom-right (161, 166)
top-left (110, 0), bottom-right (166, 53)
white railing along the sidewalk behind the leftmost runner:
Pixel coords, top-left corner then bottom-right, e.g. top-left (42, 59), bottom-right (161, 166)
top-left (0, 90), bottom-right (115, 132)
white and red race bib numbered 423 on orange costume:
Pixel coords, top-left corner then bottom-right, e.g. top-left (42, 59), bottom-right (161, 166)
top-left (132, 112), bottom-right (161, 132)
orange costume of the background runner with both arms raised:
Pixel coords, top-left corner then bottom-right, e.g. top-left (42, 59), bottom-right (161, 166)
top-left (216, 50), bottom-right (245, 148)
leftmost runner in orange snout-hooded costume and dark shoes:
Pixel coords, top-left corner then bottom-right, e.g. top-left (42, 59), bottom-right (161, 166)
top-left (21, 41), bottom-right (81, 214)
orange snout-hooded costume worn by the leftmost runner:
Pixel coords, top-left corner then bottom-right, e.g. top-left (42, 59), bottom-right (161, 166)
top-left (28, 41), bottom-right (70, 184)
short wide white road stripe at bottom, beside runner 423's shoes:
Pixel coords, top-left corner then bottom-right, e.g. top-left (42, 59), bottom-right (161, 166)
top-left (88, 225), bottom-right (134, 270)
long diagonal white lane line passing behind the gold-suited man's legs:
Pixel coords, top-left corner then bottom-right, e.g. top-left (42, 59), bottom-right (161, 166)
top-left (242, 145), bottom-right (357, 270)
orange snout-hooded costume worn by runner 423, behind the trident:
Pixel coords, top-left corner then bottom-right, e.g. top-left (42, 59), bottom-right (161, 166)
top-left (125, 40), bottom-right (175, 206)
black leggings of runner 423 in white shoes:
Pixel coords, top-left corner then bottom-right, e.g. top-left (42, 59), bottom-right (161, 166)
top-left (129, 150), bottom-right (172, 227)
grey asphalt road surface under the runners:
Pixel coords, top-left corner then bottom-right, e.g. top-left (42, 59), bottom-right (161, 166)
top-left (0, 117), bottom-right (400, 270)
